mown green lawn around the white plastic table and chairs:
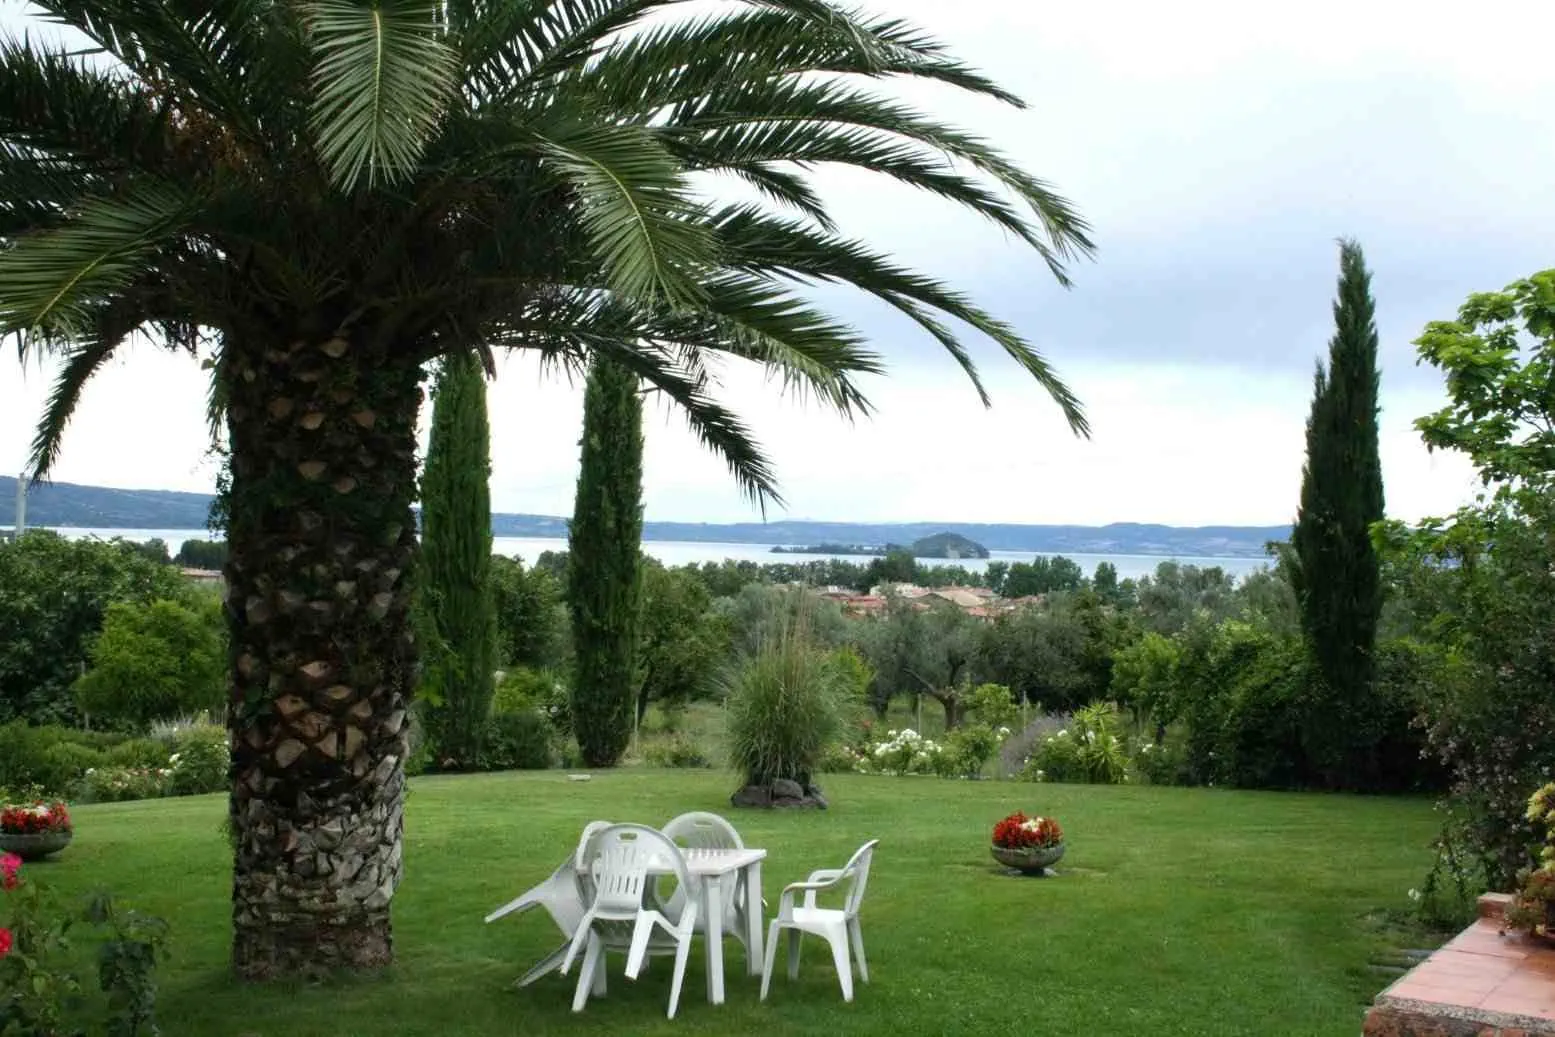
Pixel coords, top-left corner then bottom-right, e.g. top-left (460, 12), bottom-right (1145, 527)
top-left (30, 770), bottom-right (1435, 1037)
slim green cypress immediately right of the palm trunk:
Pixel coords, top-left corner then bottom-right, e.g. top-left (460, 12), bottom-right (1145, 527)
top-left (418, 353), bottom-right (498, 768)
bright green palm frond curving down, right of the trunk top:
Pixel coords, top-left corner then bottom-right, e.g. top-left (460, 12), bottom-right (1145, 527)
top-left (535, 120), bottom-right (712, 305)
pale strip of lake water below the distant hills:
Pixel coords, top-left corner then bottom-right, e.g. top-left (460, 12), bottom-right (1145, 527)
top-left (39, 525), bottom-right (1269, 578)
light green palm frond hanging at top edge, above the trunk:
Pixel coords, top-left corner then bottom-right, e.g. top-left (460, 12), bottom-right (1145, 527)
top-left (302, 0), bottom-right (459, 190)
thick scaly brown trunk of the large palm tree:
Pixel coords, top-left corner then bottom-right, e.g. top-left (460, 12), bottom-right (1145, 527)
top-left (221, 336), bottom-right (421, 979)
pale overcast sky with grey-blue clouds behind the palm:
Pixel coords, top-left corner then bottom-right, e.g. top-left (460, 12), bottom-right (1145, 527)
top-left (0, 0), bottom-right (1555, 525)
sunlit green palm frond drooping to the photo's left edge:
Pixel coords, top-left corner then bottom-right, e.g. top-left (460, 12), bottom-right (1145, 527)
top-left (0, 185), bottom-right (196, 336)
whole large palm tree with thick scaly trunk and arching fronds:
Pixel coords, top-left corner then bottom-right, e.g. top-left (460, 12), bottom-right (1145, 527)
top-left (0, 0), bottom-right (1090, 978)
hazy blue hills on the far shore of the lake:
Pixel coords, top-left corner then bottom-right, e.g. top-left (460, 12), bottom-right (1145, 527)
top-left (0, 476), bottom-right (1291, 558)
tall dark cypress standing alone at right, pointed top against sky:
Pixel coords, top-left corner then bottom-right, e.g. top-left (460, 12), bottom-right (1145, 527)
top-left (1291, 241), bottom-right (1382, 785)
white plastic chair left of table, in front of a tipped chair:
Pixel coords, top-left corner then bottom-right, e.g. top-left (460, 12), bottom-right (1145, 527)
top-left (561, 824), bottom-right (697, 1018)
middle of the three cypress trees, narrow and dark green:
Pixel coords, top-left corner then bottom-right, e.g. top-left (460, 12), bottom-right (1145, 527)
top-left (568, 359), bottom-right (642, 766)
